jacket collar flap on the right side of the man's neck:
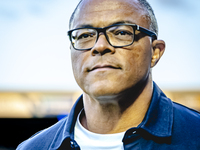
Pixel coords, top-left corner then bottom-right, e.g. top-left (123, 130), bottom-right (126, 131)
top-left (139, 83), bottom-right (173, 137)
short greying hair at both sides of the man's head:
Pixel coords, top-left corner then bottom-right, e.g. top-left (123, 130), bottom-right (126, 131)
top-left (69, 0), bottom-right (158, 35)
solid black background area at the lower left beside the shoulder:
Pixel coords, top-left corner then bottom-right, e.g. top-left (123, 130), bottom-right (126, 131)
top-left (0, 117), bottom-right (58, 150)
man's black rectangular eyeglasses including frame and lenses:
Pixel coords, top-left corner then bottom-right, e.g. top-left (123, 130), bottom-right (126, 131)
top-left (68, 23), bottom-right (157, 50)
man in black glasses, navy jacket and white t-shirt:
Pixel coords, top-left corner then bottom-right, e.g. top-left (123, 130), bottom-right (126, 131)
top-left (17, 0), bottom-right (200, 150)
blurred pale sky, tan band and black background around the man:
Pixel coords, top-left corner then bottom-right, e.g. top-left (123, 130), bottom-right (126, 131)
top-left (0, 0), bottom-right (200, 150)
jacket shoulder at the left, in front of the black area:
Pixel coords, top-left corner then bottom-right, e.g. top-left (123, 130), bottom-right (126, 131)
top-left (17, 117), bottom-right (68, 150)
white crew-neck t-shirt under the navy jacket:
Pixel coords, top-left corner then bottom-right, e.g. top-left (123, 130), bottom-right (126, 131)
top-left (74, 110), bottom-right (125, 150)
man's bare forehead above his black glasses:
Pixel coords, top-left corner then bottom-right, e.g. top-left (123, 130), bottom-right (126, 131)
top-left (72, 0), bottom-right (149, 28)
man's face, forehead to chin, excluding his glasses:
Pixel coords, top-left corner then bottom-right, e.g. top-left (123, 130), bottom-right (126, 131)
top-left (71, 0), bottom-right (152, 98)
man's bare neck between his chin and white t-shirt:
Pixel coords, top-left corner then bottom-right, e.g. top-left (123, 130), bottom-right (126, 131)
top-left (81, 77), bottom-right (153, 134)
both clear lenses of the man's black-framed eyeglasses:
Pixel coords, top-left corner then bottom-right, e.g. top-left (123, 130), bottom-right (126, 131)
top-left (71, 25), bottom-right (134, 49)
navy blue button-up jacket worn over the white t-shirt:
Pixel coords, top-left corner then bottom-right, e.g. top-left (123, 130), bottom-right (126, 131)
top-left (17, 83), bottom-right (200, 150)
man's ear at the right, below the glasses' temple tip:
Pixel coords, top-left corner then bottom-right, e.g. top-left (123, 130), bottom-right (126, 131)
top-left (151, 40), bottom-right (165, 68)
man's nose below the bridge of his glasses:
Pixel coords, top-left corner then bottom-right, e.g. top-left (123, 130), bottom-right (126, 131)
top-left (91, 33), bottom-right (115, 56)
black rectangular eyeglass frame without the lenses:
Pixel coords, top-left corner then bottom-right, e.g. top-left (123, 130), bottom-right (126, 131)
top-left (67, 23), bottom-right (157, 51)
